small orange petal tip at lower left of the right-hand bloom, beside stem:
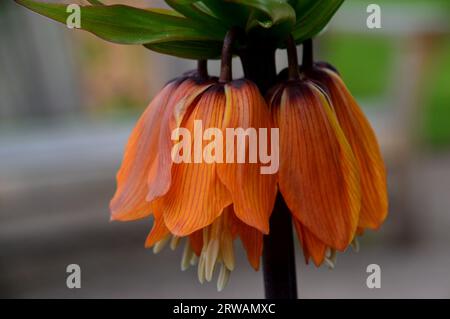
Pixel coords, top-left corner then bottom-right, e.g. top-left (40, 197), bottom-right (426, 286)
top-left (293, 218), bottom-right (327, 267)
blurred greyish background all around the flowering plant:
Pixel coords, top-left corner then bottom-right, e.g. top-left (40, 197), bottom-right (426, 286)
top-left (0, 0), bottom-right (450, 298)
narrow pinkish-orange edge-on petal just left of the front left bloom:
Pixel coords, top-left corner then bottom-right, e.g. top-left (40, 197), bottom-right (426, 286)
top-left (147, 79), bottom-right (211, 202)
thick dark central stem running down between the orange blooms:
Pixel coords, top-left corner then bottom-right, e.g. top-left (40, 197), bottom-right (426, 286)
top-left (239, 43), bottom-right (297, 299)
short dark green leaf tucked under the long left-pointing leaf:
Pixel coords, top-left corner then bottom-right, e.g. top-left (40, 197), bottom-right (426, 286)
top-left (145, 41), bottom-right (222, 60)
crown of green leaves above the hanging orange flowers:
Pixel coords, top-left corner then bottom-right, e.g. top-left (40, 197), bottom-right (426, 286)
top-left (16, 0), bottom-right (344, 59)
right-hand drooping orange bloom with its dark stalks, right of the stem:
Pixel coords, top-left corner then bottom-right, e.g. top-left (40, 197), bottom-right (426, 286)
top-left (268, 38), bottom-right (387, 267)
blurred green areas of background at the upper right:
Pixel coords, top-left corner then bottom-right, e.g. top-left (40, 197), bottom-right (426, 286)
top-left (320, 0), bottom-right (450, 150)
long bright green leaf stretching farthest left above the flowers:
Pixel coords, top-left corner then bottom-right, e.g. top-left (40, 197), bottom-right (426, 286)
top-left (16, 0), bottom-right (222, 44)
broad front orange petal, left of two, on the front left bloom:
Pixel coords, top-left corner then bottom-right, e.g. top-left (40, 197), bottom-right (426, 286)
top-left (153, 85), bottom-right (231, 236)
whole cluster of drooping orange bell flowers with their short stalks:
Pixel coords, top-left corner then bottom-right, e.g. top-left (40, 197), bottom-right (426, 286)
top-left (111, 32), bottom-right (387, 290)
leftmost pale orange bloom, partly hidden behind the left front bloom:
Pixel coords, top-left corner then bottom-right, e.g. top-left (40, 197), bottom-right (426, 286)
top-left (110, 68), bottom-right (213, 221)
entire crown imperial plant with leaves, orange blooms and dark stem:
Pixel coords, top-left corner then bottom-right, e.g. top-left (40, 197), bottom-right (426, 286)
top-left (16, 0), bottom-right (387, 298)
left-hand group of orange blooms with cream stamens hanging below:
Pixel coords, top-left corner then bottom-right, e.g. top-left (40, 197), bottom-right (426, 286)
top-left (111, 64), bottom-right (276, 290)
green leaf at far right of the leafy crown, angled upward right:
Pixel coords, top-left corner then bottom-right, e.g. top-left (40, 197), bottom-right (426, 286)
top-left (291, 0), bottom-right (344, 43)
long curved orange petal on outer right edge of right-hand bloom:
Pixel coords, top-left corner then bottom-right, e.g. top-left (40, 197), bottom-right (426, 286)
top-left (312, 69), bottom-right (388, 229)
